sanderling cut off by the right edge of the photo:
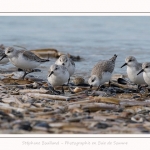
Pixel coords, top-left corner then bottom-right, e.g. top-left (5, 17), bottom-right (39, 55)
top-left (137, 62), bottom-right (150, 85)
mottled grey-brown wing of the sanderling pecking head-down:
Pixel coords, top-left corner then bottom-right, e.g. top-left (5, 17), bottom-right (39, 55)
top-left (91, 61), bottom-right (115, 78)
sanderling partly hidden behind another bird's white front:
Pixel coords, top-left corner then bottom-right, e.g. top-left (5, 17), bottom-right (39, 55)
top-left (55, 55), bottom-right (75, 83)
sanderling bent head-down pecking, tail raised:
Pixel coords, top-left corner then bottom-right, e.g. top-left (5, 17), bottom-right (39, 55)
top-left (88, 54), bottom-right (117, 88)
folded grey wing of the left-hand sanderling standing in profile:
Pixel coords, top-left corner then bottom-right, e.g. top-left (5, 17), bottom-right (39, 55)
top-left (23, 51), bottom-right (49, 62)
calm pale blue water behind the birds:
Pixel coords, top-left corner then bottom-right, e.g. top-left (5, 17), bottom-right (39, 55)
top-left (0, 16), bottom-right (150, 79)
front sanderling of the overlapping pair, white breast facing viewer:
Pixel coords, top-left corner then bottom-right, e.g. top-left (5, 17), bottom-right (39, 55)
top-left (47, 64), bottom-right (69, 93)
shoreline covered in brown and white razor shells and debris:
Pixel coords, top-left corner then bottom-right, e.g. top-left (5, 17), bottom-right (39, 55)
top-left (0, 74), bottom-right (150, 134)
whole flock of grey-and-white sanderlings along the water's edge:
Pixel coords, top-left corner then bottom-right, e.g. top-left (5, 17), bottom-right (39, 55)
top-left (0, 45), bottom-right (150, 92)
